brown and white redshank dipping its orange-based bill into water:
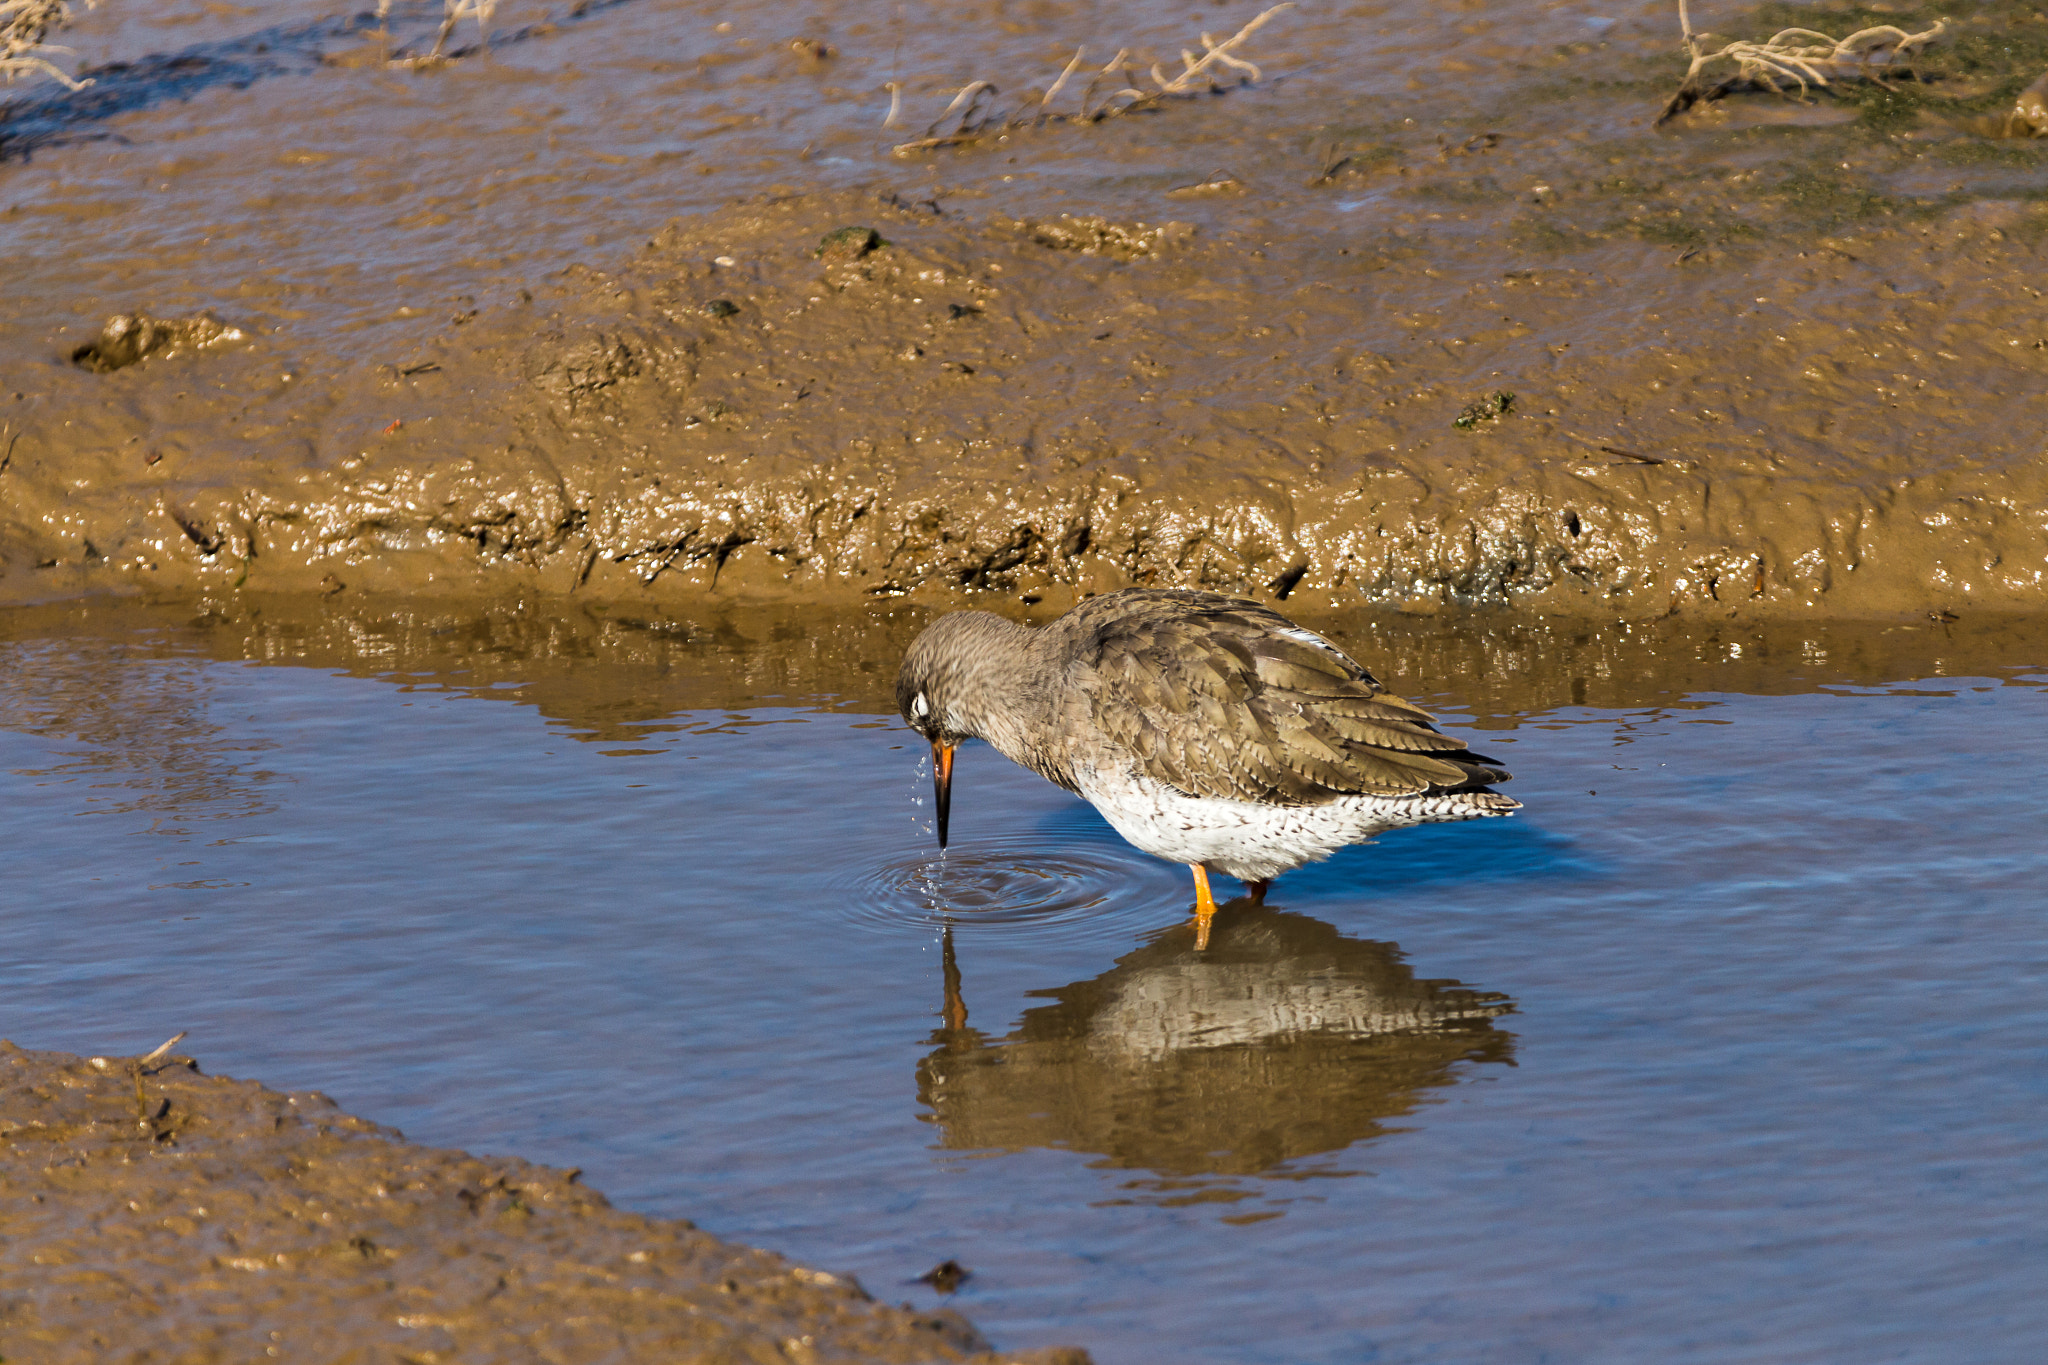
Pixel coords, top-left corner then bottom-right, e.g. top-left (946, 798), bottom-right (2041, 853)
top-left (897, 587), bottom-right (1522, 950)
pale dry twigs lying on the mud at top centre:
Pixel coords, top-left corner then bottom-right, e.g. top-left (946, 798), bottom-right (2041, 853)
top-left (883, 0), bottom-right (1294, 153)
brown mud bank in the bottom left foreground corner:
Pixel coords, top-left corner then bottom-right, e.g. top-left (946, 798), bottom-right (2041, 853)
top-left (0, 1042), bottom-right (1087, 1365)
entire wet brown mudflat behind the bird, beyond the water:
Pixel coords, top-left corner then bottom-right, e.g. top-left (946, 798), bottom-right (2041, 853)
top-left (0, 2), bottom-right (2048, 618)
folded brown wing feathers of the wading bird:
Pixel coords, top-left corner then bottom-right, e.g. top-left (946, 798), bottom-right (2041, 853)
top-left (1077, 593), bottom-right (1507, 804)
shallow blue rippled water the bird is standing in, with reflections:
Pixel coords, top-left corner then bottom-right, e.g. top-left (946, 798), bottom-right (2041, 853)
top-left (0, 610), bottom-right (2048, 1363)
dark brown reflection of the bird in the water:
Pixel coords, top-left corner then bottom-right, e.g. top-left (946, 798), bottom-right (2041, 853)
top-left (918, 900), bottom-right (1513, 1201)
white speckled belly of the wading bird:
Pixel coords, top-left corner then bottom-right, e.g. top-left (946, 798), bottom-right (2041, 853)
top-left (1075, 772), bottom-right (1520, 882)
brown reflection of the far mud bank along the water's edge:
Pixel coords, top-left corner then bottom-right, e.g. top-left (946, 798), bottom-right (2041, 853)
top-left (0, 596), bottom-right (2048, 732)
